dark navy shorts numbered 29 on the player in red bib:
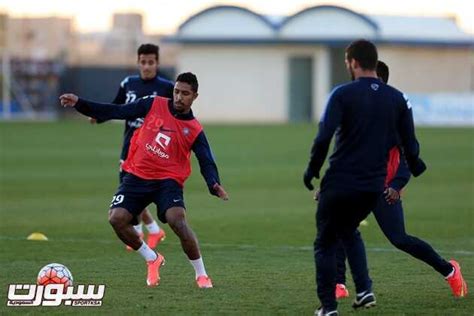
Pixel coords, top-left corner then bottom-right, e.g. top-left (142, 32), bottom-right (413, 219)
top-left (110, 172), bottom-right (186, 224)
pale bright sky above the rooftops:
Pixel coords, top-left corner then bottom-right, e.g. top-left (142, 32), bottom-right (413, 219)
top-left (0, 0), bottom-right (474, 34)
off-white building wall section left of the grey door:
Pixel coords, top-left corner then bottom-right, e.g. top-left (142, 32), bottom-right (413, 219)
top-left (177, 46), bottom-right (288, 122)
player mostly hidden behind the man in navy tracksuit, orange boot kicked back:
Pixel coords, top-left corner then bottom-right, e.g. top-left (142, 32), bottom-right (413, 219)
top-left (336, 60), bottom-right (467, 298)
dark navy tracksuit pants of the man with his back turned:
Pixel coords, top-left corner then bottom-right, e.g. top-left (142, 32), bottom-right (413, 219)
top-left (314, 187), bottom-right (382, 311)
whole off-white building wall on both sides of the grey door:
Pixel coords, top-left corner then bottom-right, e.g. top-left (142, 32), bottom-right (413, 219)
top-left (178, 45), bottom-right (474, 122)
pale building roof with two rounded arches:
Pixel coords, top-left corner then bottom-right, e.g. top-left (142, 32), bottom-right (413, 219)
top-left (164, 5), bottom-right (474, 47)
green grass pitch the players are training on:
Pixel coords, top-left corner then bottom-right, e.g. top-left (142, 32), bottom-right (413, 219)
top-left (0, 120), bottom-right (474, 315)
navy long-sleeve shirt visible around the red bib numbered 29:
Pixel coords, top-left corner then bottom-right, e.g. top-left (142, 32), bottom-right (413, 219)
top-left (75, 96), bottom-right (220, 195)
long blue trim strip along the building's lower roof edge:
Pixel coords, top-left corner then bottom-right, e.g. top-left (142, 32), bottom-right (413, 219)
top-left (161, 36), bottom-right (474, 48)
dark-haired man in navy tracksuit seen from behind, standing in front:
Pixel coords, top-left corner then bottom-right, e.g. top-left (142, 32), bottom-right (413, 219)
top-left (304, 40), bottom-right (426, 315)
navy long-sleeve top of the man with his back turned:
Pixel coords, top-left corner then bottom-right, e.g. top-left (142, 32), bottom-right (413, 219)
top-left (308, 77), bottom-right (426, 192)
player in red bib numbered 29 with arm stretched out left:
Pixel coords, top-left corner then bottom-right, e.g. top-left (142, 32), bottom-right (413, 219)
top-left (60, 72), bottom-right (228, 288)
